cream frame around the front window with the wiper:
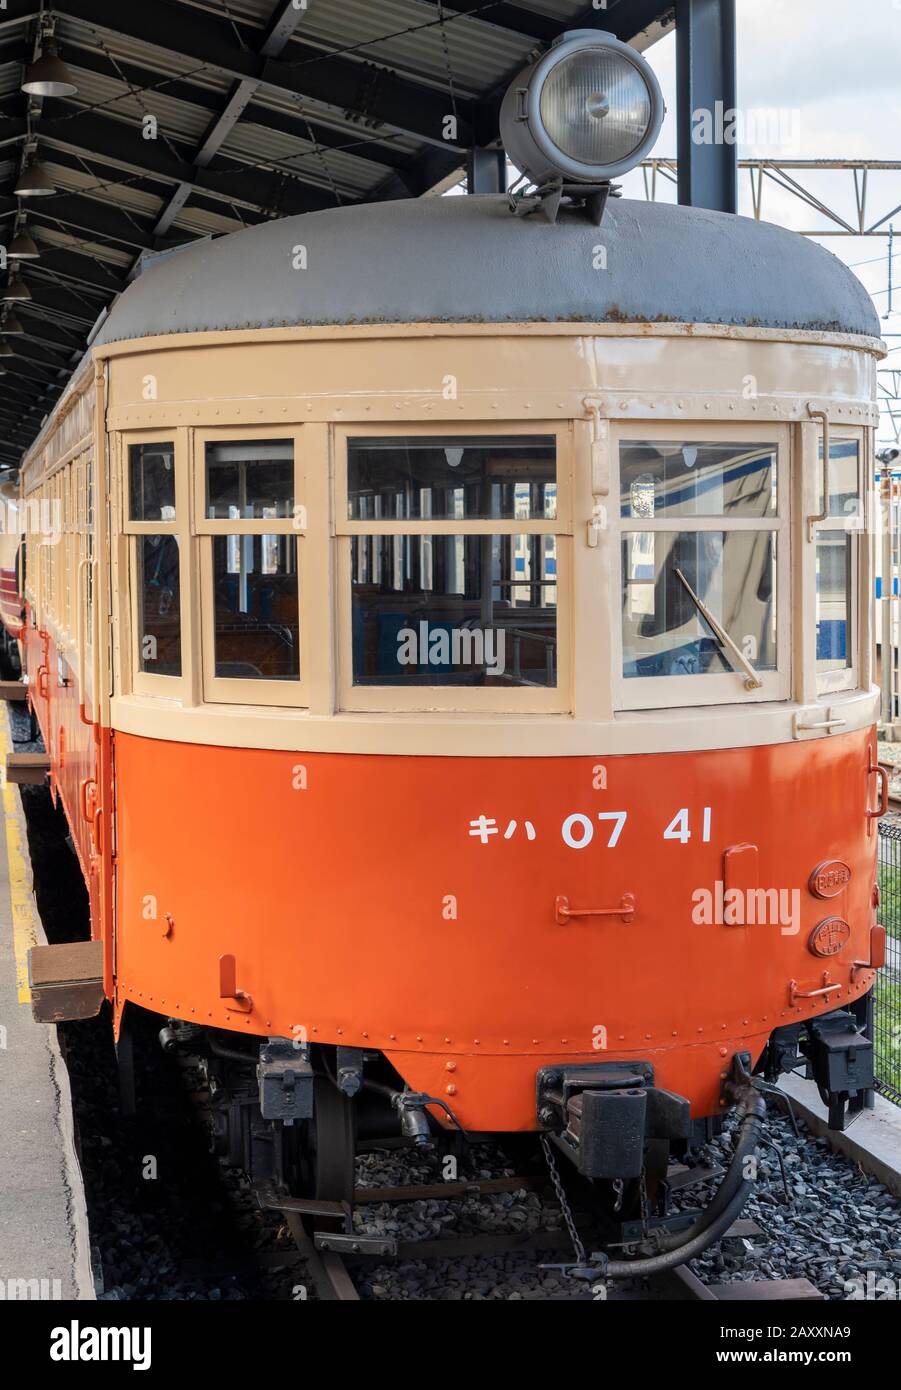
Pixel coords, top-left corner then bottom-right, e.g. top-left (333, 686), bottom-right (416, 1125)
top-left (610, 420), bottom-right (794, 713)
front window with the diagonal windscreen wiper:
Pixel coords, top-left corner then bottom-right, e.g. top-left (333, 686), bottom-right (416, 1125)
top-left (619, 436), bottom-right (790, 709)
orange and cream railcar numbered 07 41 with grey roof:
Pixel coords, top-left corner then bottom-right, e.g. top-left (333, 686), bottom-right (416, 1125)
top-left (14, 31), bottom-right (887, 1275)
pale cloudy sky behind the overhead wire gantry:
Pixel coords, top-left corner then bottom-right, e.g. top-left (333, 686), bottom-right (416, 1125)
top-left (622, 0), bottom-right (901, 442)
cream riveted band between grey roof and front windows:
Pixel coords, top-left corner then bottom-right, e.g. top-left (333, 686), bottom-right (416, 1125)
top-left (97, 324), bottom-right (884, 431)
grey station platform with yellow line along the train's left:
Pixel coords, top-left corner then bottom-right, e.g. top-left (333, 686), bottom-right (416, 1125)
top-left (0, 705), bottom-right (95, 1300)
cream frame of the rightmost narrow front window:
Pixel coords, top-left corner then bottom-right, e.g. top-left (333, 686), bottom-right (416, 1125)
top-left (805, 423), bottom-right (869, 699)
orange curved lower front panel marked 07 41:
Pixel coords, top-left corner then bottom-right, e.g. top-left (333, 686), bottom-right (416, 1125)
top-left (114, 731), bottom-right (876, 1130)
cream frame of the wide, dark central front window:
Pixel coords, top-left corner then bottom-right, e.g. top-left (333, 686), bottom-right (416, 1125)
top-left (332, 418), bottom-right (576, 714)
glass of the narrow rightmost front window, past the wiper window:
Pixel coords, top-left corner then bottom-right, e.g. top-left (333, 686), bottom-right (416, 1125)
top-left (815, 438), bottom-right (863, 694)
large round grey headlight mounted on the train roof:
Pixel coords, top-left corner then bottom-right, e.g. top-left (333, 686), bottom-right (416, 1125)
top-left (501, 29), bottom-right (665, 185)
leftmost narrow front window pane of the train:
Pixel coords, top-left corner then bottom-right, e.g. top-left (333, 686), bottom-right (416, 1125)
top-left (125, 439), bottom-right (182, 685)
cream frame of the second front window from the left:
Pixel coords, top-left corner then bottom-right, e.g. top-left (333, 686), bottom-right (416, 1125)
top-left (190, 424), bottom-right (307, 710)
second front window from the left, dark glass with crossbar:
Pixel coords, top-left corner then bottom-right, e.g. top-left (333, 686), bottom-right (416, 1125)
top-left (195, 432), bottom-right (305, 705)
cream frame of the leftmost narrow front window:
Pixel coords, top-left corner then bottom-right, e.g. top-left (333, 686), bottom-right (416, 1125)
top-left (120, 425), bottom-right (193, 703)
